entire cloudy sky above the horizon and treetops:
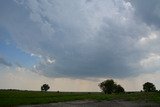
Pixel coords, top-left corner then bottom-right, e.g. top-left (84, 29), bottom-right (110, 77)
top-left (0, 0), bottom-right (160, 92)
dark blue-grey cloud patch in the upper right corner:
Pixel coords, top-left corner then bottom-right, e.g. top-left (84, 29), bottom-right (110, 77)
top-left (130, 0), bottom-right (160, 28)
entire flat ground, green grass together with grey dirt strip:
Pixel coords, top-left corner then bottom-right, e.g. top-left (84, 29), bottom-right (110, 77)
top-left (0, 90), bottom-right (160, 107)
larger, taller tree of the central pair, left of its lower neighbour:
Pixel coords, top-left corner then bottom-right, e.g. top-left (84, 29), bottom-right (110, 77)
top-left (99, 79), bottom-right (115, 94)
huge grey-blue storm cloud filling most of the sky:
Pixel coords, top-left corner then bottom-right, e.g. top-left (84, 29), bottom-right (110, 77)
top-left (1, 0), bottom-right (160, 78)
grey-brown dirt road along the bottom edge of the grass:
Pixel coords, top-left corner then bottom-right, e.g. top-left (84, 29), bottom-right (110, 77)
top-left (19, 100), bottom-right (160, 107)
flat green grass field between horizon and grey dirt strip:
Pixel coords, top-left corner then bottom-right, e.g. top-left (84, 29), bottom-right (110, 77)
top-left (0, 90), bottom-right (160, 107)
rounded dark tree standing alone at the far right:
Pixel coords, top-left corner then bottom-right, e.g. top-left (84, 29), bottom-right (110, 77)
top-left (143, 82), bottom-right (156, 92)
